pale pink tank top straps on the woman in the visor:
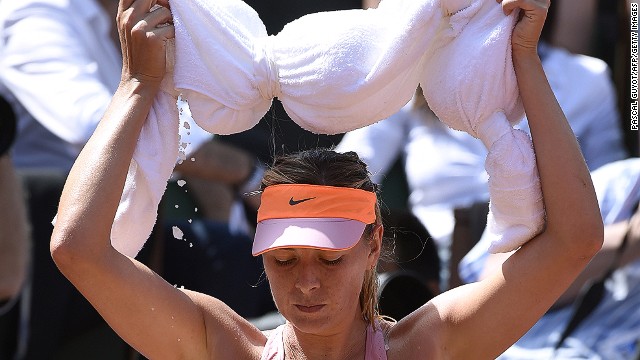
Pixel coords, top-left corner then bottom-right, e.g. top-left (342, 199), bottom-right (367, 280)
top-left (260, 325), bottom-right (387, 360)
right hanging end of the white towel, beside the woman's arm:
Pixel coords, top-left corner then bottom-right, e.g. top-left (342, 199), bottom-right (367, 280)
top-left (421, 1), bottom-right (544, 253)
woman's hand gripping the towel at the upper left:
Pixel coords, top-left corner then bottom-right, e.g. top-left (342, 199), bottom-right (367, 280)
top-left (116, 0), bottom-right (175, 86)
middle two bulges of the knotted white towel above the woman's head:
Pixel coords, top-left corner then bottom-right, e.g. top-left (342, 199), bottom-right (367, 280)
top-left (172, 0), bottom-right (450, 134)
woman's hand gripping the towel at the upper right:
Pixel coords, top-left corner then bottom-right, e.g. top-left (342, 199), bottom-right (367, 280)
top-left (496, 0), bottom-right (551, 52)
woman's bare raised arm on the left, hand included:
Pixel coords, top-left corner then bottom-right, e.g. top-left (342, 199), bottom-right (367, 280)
top-left (51, 0), bottom-right (218, 359)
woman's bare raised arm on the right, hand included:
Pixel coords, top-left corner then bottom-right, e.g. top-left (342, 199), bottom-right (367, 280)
top-left (402, 0), bottom-right (603, 359)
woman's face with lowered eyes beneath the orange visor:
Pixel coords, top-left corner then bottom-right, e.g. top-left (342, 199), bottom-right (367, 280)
top-left (263, 227), bottom-right (382, 336)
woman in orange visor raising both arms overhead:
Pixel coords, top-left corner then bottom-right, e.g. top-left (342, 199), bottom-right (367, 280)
top-left (51, 0), bottom-right (603, 360)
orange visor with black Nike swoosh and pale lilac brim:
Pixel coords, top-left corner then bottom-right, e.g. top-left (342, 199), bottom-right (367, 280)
top-left (252, 184), bottom-right (377, 256)
